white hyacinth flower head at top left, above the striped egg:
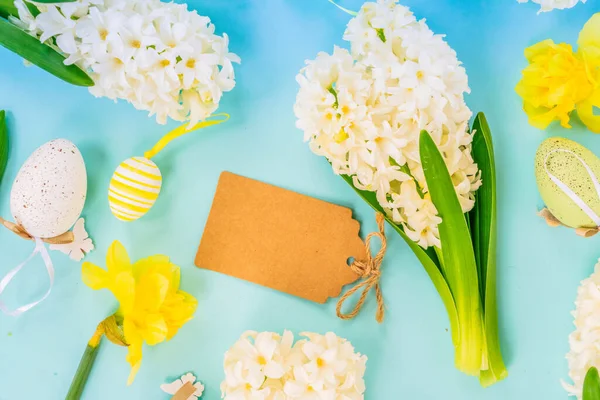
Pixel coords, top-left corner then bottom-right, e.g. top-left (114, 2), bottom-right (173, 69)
top-left (13, 0), bottom-right (240, 125)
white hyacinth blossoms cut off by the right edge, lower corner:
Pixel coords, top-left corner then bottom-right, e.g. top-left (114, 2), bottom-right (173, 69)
top-left (563, 260), bottom-right (600, 400)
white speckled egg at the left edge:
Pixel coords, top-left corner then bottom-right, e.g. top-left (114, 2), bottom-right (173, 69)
top-left (10, 139), bottom-right (87, 239)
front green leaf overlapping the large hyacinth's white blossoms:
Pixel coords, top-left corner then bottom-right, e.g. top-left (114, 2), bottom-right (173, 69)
top-left (419, 131), bottom-right (484, 376)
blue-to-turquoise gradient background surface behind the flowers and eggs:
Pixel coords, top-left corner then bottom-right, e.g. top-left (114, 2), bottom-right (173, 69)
top-left (0, 0), bottom-right (600, 400)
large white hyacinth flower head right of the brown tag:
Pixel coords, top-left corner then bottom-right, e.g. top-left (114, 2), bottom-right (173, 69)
top-left (294, 0), bottom-right (481, 247)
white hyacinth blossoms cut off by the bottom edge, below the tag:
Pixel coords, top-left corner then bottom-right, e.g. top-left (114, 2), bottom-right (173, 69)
top-left (221, 331), bottom-right (367, 400)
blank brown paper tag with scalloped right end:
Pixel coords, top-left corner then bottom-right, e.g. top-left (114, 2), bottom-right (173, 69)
top-left (196, 172), bottom-right (366, 303)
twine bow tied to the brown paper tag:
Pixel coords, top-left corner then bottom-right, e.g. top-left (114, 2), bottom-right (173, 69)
top-left (336, 213), bottom-right (387, 323)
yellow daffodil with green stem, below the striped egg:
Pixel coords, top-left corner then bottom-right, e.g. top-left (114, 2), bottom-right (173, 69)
top-left (69, 241), bottom-right (198, 398)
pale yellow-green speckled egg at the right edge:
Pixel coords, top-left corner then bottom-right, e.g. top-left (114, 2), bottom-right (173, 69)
top-left (535, 137), bottom-right (600, 228)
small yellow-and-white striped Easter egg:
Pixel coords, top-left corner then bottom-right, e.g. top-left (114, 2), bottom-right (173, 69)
top-left (108, 157), bottom-right (162, 221)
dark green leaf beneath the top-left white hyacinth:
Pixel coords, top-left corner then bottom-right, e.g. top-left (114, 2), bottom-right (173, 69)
top-left (0, 18), bottom-right (94, 86)
